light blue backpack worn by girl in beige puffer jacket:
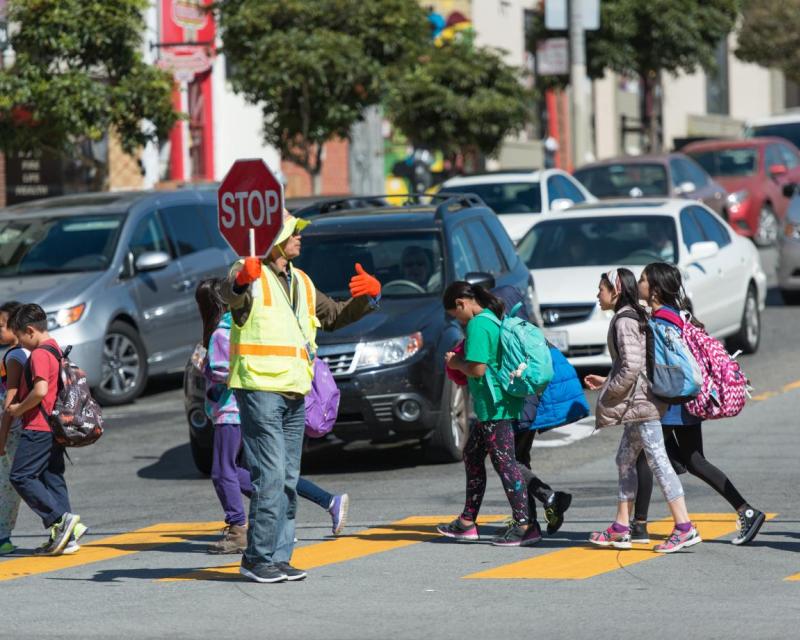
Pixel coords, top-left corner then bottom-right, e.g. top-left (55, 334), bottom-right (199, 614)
top-left (613, 311), bottom-right (703, 404)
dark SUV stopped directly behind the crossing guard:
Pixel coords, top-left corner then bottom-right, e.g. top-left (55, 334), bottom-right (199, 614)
top-left (185, 195), bottom-right (540, 471)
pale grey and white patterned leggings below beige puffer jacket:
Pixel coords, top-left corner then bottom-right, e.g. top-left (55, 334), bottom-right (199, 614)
top-left (617, 420), bottom-right (683, 502)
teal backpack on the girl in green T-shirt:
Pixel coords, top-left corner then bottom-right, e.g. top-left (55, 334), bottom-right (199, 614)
top-left (476, 302), bottom-right (553, 403)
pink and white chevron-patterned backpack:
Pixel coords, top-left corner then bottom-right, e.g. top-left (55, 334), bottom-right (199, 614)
top-left (683, 316), bottom-right (750, 420)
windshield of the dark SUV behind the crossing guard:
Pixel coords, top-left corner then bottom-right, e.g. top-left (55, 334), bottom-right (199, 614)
top-left (294, 232), bottom-right (444, 299)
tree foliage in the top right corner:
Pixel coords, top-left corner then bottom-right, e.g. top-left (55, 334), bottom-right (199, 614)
top-left (736, 0), bottom-right (800, 83)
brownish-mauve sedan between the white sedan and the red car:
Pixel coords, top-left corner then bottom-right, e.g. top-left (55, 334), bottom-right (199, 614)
top-left (575, 153), bottom-right (728, 216)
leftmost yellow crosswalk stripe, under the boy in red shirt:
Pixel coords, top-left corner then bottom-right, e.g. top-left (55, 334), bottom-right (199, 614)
top-left (0, 522), bottom-right (224, 581)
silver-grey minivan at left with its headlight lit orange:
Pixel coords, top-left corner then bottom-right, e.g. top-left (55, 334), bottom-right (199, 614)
top-left (0, 189), bottom-right (234, 405)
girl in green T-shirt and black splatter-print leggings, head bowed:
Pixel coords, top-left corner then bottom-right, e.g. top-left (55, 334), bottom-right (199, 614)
top-left (437, 281), bottom-right (542, 547)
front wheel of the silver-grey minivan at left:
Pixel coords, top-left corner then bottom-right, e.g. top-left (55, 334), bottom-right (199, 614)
top-left (94, 321), bottom-right (147, 406)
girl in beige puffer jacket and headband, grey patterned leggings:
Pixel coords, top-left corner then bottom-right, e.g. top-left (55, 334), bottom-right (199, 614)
top-left (584, 269), bottom-right (701, 553)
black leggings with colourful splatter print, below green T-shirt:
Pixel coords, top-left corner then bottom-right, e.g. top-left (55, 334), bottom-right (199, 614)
top-left (461, 420), bottom-right (528, 524)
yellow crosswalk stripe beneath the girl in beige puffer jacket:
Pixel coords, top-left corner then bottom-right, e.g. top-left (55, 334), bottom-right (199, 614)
top-left (464, 513), bottom-right (776, 580)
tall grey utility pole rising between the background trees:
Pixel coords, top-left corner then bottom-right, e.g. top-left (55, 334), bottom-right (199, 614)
top-left (568, 0), bottom-right (591, 168)
